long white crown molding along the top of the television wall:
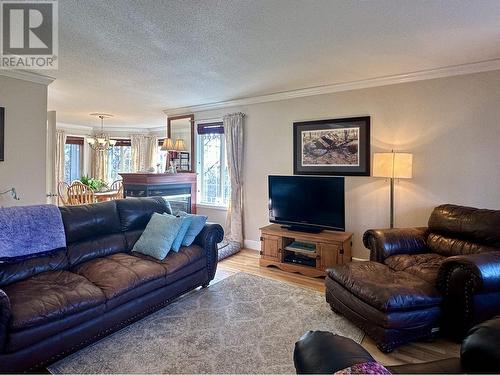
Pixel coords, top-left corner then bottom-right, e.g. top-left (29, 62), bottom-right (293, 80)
top-left (163, 58), bottom-right (500, 116)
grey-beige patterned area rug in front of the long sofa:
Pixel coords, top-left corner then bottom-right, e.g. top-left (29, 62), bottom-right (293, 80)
top-left (49, 273), bottom-right (363, 374)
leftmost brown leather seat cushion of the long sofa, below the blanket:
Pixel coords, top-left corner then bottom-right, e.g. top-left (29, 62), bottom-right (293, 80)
top-left (3, 271), bottom-right (105, 330)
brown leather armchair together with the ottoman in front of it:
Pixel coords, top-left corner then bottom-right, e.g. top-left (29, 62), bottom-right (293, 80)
top-left (325, 204), bottom-right (500, 352)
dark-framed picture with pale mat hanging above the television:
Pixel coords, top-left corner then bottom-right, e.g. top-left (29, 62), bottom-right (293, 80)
top-left (293, 116), bottom-right (370, 176)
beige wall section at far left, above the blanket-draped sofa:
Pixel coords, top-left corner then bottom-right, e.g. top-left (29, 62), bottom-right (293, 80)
top-left (0, 75), bottom-right (47, 206)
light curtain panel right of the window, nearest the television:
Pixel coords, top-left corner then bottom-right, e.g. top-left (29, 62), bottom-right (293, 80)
top-left (223, 112), bottom-right (245, 246)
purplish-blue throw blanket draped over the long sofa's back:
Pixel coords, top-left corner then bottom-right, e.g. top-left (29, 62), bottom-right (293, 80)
top-left (0, 204), bottom-right (66, 262)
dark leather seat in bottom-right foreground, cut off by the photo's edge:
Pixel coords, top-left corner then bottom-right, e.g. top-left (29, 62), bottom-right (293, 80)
top-left (293, 317), bottom-right (500, 374)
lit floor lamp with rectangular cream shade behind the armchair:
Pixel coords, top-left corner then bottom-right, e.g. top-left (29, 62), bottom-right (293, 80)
top-left (373, 151), bottom-right (413, 228)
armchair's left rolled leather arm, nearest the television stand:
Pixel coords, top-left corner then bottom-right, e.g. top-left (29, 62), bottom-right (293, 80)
top-left (363, 227), bottom-right (429, 263)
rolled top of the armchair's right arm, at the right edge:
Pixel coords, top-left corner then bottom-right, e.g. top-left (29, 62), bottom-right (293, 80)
top-left (437, 251), bottom-right (500, 295)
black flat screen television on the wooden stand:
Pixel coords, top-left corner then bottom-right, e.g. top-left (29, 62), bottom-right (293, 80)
top-left (268, 176), bottom-right (345, 232)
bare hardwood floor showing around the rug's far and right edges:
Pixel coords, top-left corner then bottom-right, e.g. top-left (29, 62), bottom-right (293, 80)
top-left (217, 249), bottom-right (460, 365)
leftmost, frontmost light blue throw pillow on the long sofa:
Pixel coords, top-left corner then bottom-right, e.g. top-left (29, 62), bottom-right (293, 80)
top-left (132, 212), bottom-right (182, 260)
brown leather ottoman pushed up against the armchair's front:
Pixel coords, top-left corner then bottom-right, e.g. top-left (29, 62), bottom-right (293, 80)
top-left (325, 262), bottom-right (441, 353)
